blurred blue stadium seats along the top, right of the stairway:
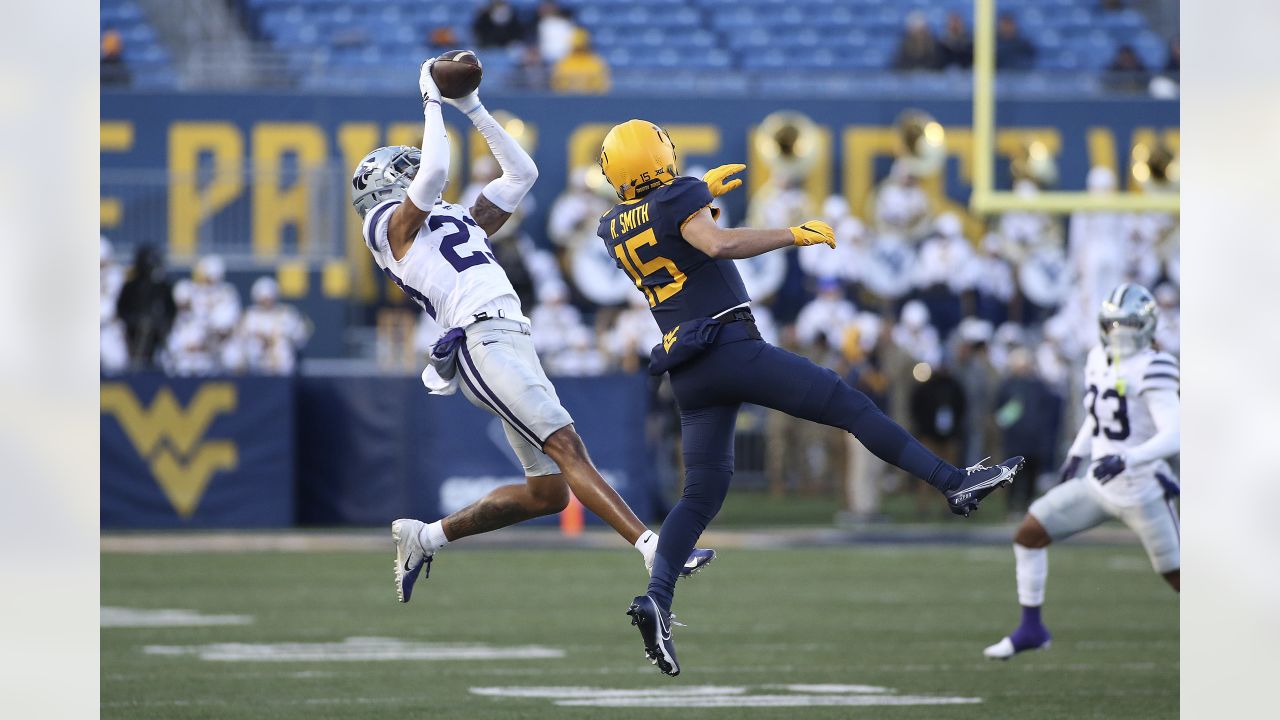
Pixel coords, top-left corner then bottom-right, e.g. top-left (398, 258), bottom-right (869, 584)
top-left (222, 0), bottom-right (1166, 91)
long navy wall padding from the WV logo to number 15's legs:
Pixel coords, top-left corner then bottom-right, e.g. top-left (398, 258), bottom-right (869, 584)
top-left (101, 374), bottom-right (660, 529)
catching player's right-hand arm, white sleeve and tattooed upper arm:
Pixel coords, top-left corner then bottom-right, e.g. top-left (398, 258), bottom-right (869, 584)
top-left (444, 90), bottom-right (538, 234)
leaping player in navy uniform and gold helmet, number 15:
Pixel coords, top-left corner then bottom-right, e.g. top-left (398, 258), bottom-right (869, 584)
top-left (598, 120), bottom-right (1023, 675)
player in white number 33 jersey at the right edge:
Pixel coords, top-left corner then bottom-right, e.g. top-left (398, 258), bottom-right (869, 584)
top-left (983, 283), bottom-right (1180, 660)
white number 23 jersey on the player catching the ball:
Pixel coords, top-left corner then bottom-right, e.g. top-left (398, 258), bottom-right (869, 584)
top-left (364, 200), bottom-right (529, 328)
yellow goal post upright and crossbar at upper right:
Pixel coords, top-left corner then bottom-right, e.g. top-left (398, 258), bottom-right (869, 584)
top-left (969, 0), bottom-right (1179, 215)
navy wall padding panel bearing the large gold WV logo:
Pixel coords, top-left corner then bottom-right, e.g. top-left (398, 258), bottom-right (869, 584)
top-left (101, 375), bottom-right (293, 528)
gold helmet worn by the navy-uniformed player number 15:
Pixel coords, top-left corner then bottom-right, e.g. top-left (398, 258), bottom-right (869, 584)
top-left (600, 120), bottom-right (676, 200)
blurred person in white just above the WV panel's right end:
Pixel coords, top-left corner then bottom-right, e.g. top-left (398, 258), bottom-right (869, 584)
top-left (237, 278), bottom-right (311, 375)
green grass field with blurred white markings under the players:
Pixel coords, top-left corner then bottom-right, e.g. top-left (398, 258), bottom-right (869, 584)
top-left (101, 539), bottom-right (1179, 720)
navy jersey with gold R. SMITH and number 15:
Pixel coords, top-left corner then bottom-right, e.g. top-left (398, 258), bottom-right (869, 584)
top-left (596, 177), bottom-right (750, 333)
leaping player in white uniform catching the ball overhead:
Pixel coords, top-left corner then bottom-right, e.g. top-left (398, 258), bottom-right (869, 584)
top-left (351, 60), bottom-right (714, 602)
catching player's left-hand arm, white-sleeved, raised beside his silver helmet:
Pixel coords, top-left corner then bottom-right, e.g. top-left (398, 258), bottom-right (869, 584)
top-left (387, 60), bottom-right (449, 260)
